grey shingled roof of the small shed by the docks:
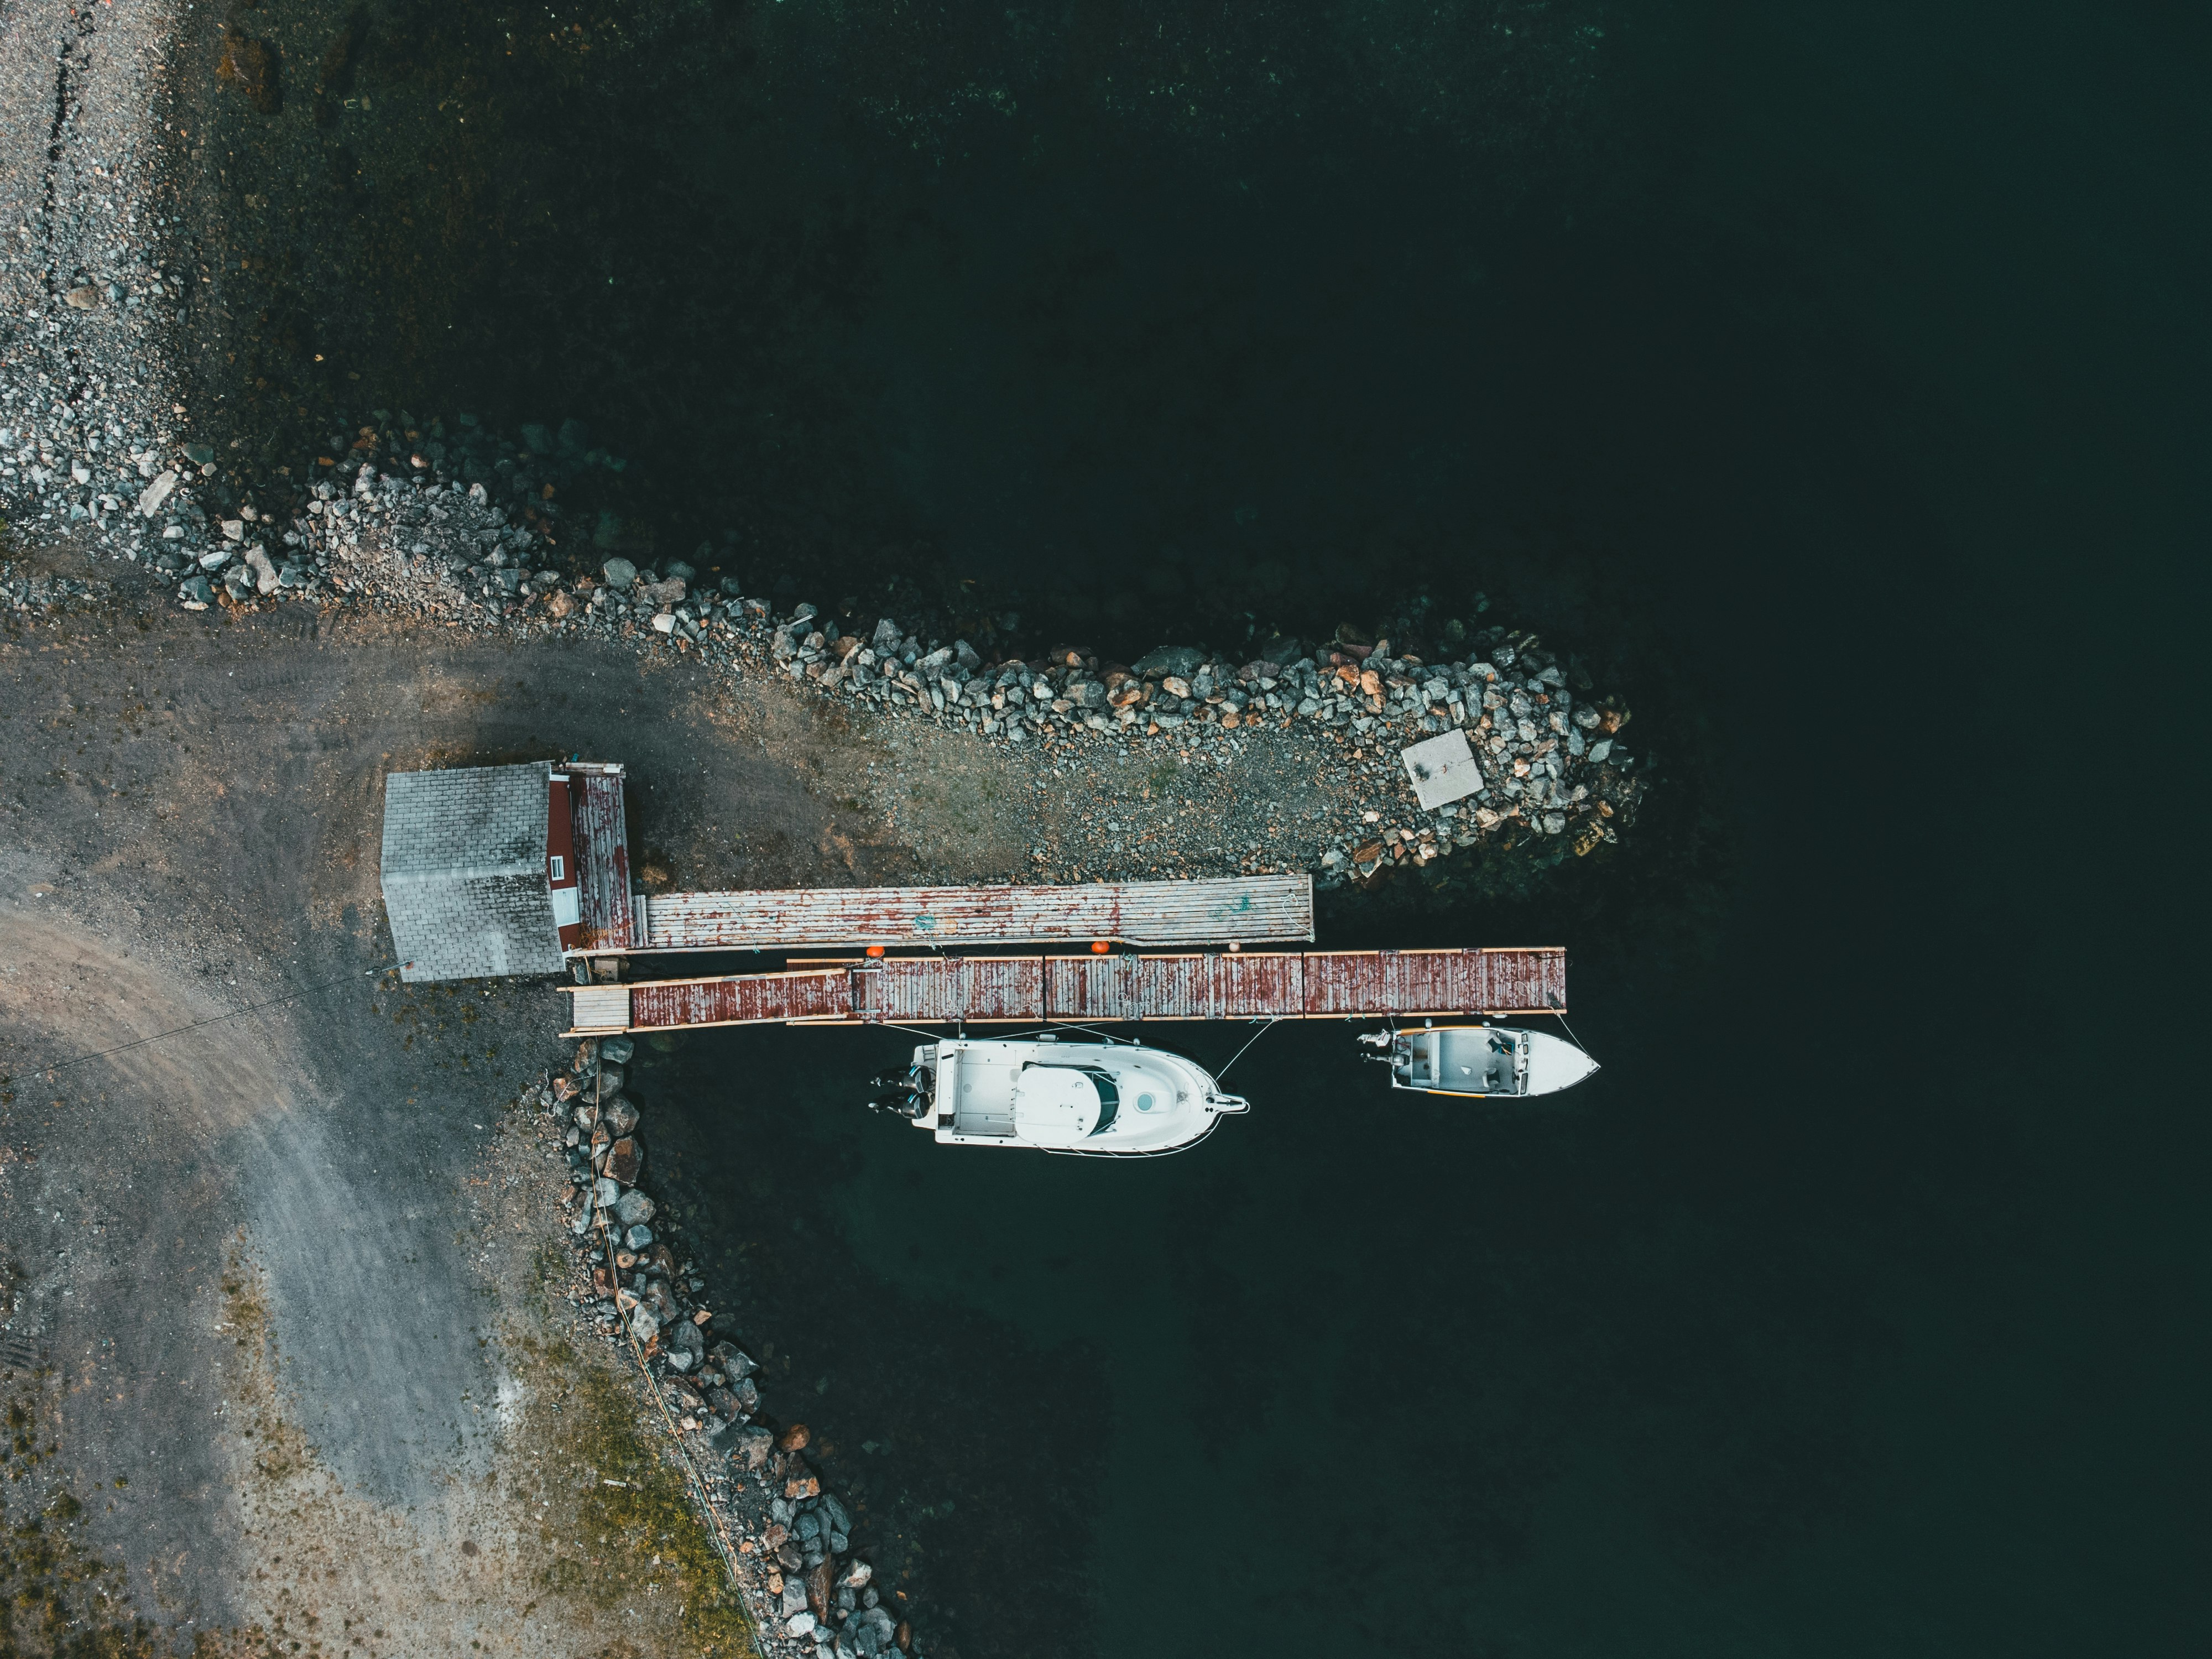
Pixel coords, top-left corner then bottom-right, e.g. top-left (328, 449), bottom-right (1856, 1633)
top-left (383, 761), bottom-right (562, 980)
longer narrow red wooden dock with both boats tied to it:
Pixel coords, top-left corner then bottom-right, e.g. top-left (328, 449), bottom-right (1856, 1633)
top-left (562, 947), bottom-right (1566, 1037)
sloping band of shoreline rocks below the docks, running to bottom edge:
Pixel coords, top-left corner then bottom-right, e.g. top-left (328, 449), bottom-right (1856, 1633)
top-left (535, 1037), bottom-right (922, 1659)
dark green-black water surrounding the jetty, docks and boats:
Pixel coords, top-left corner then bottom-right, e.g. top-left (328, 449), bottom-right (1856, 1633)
top-left (199, 2), bottom-right (2212, 1659)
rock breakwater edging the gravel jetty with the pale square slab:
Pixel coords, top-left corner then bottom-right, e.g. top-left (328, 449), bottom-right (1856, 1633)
top-left (0, 438), bottom-right (1646, 885)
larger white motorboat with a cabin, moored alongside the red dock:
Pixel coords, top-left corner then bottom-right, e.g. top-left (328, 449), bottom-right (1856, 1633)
top-left (896, 1037), bottom-right (1250, 1157)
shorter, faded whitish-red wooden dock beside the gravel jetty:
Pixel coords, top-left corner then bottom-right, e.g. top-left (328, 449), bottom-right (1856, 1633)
top-left (633, 876), bottom-right (1314, 951)
